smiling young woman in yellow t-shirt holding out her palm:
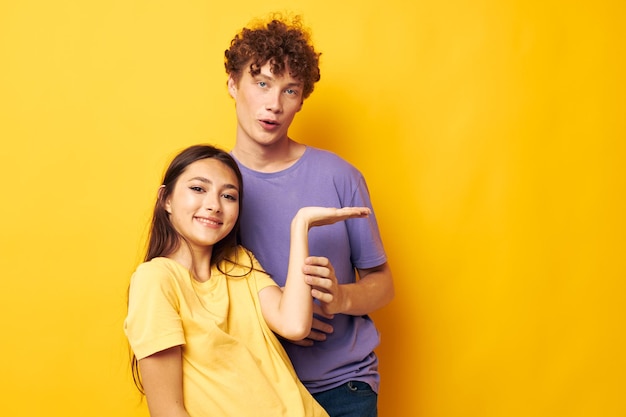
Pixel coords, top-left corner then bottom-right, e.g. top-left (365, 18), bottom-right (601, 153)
top-left (124, 145), bottom-right (369, 417)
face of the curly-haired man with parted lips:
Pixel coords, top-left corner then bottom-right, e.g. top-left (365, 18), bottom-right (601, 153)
top-left (228, 63), bottom-right (303, 146)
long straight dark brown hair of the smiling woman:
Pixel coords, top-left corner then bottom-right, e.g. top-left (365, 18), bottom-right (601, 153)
top-left (131, 145), bottom-right (243, 394)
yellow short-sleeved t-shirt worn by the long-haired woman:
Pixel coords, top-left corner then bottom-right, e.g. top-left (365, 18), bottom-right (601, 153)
top-left (124, 247), bottom-right (328, 417)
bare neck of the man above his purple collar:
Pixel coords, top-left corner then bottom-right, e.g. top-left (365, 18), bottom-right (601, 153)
top-left (232, 139), bottom-right (306, 173)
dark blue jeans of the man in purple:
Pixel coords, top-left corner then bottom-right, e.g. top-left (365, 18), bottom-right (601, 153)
top-left (313, 381), bottom-right (378, 417)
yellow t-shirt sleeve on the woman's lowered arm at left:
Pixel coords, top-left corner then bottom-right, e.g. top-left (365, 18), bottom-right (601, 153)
top-left (124, 262), bottom-right (185, 359)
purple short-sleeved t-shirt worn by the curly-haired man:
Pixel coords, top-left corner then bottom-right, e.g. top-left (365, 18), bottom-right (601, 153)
top-left (233, 147), bottom-right (387, 393)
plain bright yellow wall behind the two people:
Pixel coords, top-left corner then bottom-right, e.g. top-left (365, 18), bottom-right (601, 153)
top-left (0, 0), bottom-right (626, 417)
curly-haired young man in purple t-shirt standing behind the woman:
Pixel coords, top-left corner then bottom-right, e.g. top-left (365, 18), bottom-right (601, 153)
top-left (225, 16), bottom-right (394, 417)
